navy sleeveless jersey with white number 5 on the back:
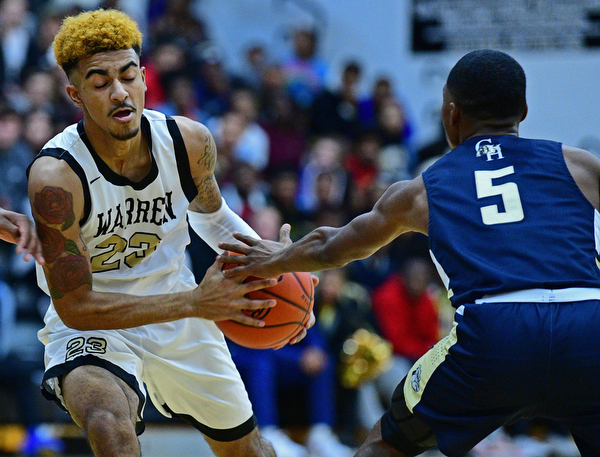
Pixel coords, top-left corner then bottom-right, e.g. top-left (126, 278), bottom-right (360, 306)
top-left (423, 136), bottom-right (600, 307)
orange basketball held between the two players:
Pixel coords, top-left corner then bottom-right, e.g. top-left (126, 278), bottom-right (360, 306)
top-left (215, 264), bottom-right (314, 349)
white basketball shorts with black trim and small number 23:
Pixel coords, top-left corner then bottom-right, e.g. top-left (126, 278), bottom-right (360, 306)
top-left (42, 318), bottom-right (256, 441)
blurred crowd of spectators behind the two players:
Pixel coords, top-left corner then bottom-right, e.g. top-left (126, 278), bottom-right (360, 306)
top-left (0, 0), bottom-right (580, 457)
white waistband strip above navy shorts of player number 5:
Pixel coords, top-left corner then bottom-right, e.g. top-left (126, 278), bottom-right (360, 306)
top-left (475, 287), bottom-right (600, 304)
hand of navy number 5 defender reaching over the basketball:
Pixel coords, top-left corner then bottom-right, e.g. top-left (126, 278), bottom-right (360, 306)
top-left (217, 224), bottom-right (292, 278)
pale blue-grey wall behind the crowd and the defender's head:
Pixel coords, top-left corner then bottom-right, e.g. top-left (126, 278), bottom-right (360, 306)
top-left (197, 0), bottom-right (600, 150)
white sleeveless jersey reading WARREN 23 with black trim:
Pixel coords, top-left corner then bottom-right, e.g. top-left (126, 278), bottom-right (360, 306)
top-left (33, 110), bottom-right (197, 318)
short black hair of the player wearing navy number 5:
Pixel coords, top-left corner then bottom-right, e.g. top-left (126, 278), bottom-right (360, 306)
top-left (446, 49), bottom-right (526, 120)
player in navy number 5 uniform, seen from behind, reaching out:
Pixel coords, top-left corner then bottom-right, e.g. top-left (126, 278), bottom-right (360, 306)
top-left (220, 50), bottom-right (600, 457)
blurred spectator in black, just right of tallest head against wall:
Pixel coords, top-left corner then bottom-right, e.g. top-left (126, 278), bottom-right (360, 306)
top-left (310, 61), bottom-right (362, 139)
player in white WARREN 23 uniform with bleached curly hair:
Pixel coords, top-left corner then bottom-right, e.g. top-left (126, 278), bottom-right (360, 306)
top-left (29, 10), bottom-right (314, 457)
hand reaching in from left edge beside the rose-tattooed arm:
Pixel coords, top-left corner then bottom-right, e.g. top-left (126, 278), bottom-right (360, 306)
top-left (0, 208), bottom-right (44, 263)
